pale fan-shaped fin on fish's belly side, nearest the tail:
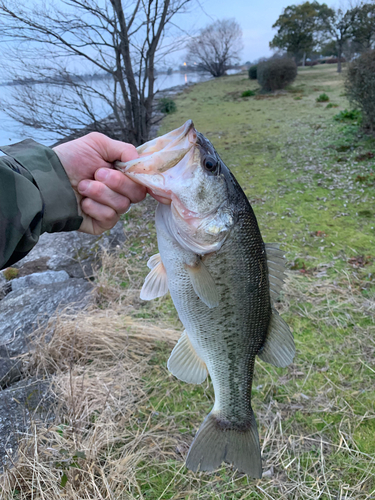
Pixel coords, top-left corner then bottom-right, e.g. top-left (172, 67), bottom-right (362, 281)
top-left (167, 332), bottom-right (207, 384)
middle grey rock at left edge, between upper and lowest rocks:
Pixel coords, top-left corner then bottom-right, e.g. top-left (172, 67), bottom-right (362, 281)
top-left (0, 278), bottom-right (93, 387)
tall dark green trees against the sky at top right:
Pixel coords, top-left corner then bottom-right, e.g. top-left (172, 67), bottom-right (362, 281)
top-left (270, 1), bottom-right (375, 72)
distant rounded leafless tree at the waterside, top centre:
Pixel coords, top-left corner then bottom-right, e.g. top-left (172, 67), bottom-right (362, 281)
top-left (188, 19), bottom-right (243, 77)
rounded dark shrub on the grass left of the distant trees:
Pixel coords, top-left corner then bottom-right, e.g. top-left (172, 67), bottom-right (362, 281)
top-left (257, 59), bottom-right (297, 92)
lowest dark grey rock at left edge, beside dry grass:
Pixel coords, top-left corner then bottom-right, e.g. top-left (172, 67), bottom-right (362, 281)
top-left (0, 379), bottom-right (52, 471)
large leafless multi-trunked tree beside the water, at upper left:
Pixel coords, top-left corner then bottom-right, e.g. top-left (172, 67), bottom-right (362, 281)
top-left (0, 0), bottom-right (191, 145)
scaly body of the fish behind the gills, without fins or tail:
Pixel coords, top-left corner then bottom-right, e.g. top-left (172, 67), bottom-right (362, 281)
top-left (156, 199), bottom-right (271, 425)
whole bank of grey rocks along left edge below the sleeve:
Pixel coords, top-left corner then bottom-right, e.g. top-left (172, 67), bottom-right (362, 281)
top-left (0, 222), bottom-right (125, 468)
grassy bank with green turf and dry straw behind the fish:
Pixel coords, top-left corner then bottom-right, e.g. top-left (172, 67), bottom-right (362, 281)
top-left (0, 67), bottom-right (375, 500)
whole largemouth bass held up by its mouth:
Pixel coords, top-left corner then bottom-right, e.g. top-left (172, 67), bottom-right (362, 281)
top-left (115, 120), bottom-right (295, 478)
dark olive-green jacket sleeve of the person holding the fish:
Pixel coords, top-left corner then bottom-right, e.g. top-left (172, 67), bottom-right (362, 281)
top-left (0, 139), bottom-right (82, 269)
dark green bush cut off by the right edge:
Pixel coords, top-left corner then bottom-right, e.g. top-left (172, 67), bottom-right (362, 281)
top-left (345, 50), bottom-right (375, 131)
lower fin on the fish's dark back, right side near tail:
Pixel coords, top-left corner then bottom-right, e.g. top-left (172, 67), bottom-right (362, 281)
top-left (258, 309), bottom-right (296, 368)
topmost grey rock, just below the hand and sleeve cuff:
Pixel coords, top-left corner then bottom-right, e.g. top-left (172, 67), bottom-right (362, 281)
top-left (16, 221), bottom-right (126, 278)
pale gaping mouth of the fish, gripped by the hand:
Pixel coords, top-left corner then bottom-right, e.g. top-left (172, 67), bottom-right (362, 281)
top-left (115, 120), bottom-right (198, 203)
